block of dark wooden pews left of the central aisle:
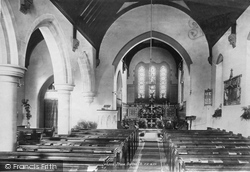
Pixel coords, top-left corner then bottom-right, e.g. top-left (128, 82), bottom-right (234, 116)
top-left (0, 128), bottom-right (139, 172)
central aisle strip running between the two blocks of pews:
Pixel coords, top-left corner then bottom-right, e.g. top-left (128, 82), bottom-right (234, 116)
top-left (128, 130), bottom-right (167, 172)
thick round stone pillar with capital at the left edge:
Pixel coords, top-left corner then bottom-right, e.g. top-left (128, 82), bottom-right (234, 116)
top-left (0, 64), bottom-right (25, 151)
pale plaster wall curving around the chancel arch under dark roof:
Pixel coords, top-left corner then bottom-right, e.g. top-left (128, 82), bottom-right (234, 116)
top-left (97, 5), bottom-right (211, 129)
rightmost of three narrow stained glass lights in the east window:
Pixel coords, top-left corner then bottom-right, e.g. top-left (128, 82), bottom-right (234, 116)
top-left (160, 66), bottom-right (167, 98)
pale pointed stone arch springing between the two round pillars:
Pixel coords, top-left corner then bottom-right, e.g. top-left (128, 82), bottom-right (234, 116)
top-left (21, 14), bottom-right (73, 85)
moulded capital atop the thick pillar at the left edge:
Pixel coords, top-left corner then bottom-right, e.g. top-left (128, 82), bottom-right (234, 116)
top-left (0, 64), bottom-right (26, 78)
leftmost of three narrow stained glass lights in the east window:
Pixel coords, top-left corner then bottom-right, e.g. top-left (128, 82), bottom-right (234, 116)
top-left (138, 66), bottom-right (146, 98)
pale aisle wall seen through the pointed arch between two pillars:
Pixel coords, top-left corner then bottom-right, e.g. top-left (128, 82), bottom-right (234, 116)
top-left (23, 41), bottom-right (53, 127)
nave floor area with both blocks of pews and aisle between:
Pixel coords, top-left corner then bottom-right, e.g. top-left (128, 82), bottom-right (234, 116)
top-left (0, 128), bottom-right (250, 172)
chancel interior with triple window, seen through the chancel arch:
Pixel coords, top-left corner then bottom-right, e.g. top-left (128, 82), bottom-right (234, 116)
top-left (118, 39), bottom-right (182, 128)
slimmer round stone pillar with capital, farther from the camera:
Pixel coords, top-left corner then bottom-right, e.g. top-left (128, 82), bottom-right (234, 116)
top-left (55, 84), bottom-right (74, 134)
